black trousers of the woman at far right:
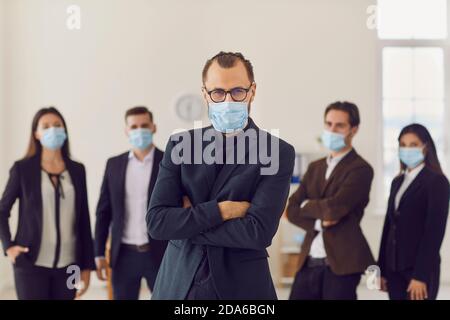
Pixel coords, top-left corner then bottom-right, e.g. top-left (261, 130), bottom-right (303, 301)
top-left (384, 267), bottom-right (440, 300)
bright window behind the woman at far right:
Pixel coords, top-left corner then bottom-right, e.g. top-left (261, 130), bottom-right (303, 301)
top-left (378, 0), bottom-right (449, 200)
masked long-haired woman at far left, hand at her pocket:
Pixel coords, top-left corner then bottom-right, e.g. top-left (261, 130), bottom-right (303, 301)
top-left (0, 107), bottom-right (95, 300)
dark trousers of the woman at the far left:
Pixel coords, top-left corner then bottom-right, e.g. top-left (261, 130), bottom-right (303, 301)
top-left (14, 265), bottom-right (76, 300)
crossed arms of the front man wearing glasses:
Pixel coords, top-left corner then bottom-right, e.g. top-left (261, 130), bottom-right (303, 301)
top-left (147, 142), bottom-right (294, 249)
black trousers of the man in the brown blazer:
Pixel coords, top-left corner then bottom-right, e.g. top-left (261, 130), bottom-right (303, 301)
top-left (289, 263), bottom-right (361, 300)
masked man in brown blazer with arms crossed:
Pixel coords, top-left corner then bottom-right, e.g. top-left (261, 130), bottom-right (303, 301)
top-left (287, 102), bottom-right (375, 300)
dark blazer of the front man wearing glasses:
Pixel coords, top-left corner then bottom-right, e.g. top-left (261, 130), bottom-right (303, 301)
top-left (147, 119), bottom-right (295, 299)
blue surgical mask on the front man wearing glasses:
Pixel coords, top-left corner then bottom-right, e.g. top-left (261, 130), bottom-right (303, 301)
top-left (209, 101), bottom-right (248, 133)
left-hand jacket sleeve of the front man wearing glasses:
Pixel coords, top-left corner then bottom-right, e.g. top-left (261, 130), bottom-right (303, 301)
top-left (146, 139), bottom-right (223, 240)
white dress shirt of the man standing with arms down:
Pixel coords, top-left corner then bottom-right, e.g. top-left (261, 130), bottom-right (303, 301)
top-left (122, 147), bottom-right (155, 246)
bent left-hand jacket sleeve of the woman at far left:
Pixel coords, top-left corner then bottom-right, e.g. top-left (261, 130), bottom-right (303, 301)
top-left (0, 162), bottom-right (21, 255)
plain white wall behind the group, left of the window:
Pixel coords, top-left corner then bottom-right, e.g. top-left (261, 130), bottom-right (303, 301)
top-left (0, 0), bottom-right (448, 292)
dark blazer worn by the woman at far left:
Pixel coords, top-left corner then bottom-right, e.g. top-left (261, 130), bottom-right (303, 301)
top-left (0, 154), bottom-right (95, 270)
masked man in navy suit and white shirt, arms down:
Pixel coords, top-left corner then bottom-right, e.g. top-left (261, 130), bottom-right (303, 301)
top-left (95, 107), bottom-right (167, 300)
